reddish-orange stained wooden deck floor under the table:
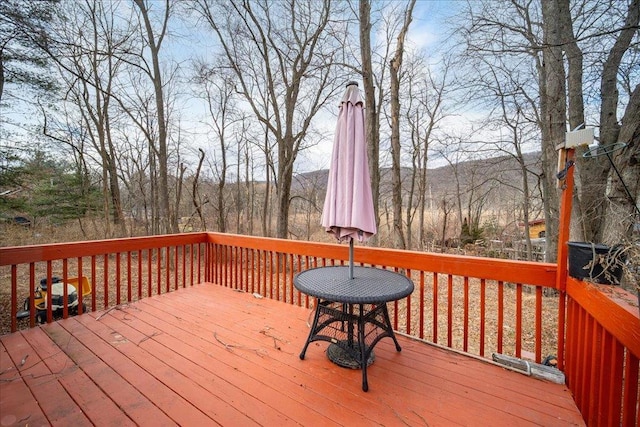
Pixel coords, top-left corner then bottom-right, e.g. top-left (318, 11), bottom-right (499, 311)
top-left (0, 284), bottom-right (584, 426)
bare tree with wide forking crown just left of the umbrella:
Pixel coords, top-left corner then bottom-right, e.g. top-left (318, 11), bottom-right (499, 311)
top-left (196, 0), bottom-right (343, 237)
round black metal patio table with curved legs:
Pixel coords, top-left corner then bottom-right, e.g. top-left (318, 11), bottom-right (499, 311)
top-left (293, 266), bottom-right (414, 391)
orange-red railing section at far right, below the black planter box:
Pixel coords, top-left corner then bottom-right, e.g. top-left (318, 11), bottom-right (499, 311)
top-left (565, 278), bottom-right (640, 426)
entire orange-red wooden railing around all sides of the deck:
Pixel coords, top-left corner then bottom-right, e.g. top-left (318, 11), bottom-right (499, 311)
top-left (0, 233), bottom-right (640, 425)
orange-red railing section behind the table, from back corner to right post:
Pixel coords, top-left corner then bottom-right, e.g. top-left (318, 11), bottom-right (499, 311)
top-left (210, 233), bottom-right (564, 362)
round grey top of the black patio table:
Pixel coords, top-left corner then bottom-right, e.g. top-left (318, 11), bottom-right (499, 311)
top-left (293, 266), bottom-right (413, 304)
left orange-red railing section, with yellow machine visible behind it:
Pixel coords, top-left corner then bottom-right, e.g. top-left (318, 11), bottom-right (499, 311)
top-left (0, 233), bottom-right (208, 333)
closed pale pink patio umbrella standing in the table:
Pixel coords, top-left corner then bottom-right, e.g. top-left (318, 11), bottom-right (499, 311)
top-left (322, 82), bottom-right (377, 278)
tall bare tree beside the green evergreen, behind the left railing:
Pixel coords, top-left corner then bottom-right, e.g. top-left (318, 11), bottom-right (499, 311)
top-left (16, 0), bottom-right (130, 236)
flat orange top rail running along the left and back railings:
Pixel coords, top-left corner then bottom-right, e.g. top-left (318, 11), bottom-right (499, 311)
top-left (0, 232), bottom-right (557, 287)
